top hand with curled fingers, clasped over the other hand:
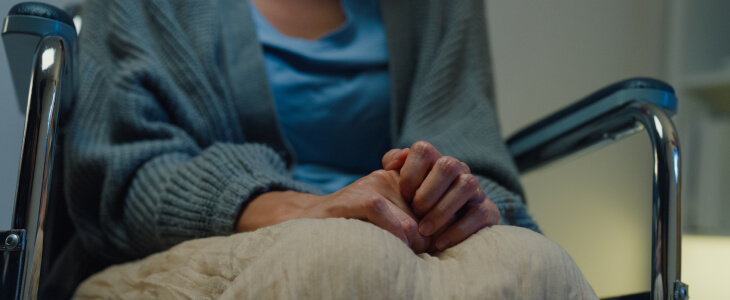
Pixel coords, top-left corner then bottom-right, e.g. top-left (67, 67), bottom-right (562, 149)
top-left (383, 141), bottom-right (502, 250)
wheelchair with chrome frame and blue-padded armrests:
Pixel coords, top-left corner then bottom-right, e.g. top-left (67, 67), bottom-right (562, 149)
top-left (0, 3), bottom-right (688, 299)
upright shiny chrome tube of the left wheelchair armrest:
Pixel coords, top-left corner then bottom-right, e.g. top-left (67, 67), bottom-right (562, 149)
top-left (12, 36), bottom-right (70, 299)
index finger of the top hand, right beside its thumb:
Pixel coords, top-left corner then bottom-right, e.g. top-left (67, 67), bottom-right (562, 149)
top-left (400, 141), bottom-right (441, 201)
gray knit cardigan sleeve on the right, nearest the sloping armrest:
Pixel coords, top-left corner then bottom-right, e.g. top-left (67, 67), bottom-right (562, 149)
top-left (397, 0), bottom-right (539, 231)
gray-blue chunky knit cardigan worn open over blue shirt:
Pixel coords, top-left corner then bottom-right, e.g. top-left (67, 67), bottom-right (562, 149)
top-left (64, 0), bottom-right (537, 264)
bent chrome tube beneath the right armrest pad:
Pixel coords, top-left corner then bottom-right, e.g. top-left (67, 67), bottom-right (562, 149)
top-left (506, 102), bottom-right (688, 299)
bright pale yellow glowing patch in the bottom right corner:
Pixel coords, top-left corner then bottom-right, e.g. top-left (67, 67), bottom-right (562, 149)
top-left (682, 235), bottom-right (730, 299)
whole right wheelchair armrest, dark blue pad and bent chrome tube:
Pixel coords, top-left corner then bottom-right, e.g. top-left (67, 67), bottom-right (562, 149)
top-left (507, 78), bottom-right (688, 299)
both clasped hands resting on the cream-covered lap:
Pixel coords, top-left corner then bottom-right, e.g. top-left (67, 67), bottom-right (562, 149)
top-left (236, 142), bottom-right (501, 253)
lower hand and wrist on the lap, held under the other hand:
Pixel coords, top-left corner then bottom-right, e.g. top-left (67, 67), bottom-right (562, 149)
top-left (236, 170), bottom-right (427, 253)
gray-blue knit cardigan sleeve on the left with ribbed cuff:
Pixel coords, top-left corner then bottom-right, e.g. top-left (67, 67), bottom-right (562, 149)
top-left (64, 1), bottom-right (317, 262)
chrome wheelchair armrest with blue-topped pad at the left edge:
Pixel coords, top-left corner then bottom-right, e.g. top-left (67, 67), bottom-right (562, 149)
top-left (0, 3), bottom-right (76, 299)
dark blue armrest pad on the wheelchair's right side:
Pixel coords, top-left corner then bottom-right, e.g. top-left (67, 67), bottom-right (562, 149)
top-left (507, 78), bottom-right (677, 157)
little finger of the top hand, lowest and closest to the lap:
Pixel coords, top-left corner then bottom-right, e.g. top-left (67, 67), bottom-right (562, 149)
top-left (435, 196), bottom-right (501, 251)
